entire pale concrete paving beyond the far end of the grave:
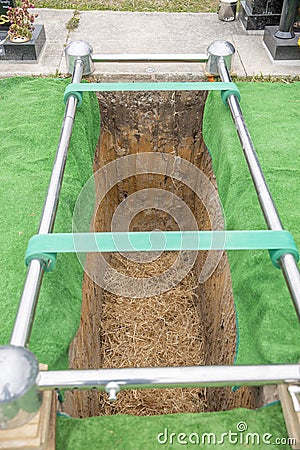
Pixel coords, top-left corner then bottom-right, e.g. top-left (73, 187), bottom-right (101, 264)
top-left (0, 9), bottom-right (300, 79)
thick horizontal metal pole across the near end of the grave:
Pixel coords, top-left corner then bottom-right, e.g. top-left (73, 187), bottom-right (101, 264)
top-left (37, 364), bottom-right (300, 390)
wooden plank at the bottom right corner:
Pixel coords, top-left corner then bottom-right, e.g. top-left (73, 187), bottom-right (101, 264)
top-left (278, 384), bottom-right (300, 450)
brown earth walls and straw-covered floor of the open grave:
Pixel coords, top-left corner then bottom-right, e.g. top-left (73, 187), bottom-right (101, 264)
top-left (66, 86), bottom-right (257, 417)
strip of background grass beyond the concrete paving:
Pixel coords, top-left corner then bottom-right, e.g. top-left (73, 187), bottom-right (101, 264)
top-left (34, 0), bottom-right (219, 13)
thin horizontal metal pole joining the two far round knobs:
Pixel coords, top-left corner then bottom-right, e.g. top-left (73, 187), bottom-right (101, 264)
top-left (92, 53), bottom-right (208, 63)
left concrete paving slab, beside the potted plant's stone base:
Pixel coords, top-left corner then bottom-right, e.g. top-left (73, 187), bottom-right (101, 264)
top-left (0, 9), bottom-right (73, 78)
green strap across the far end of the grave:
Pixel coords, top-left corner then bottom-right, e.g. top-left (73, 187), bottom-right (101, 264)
top-left (64, 81), bottom-right (241, 106)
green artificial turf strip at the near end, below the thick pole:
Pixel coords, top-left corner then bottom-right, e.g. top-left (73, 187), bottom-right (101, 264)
top-left (57, 404), bottom-right (290, 450)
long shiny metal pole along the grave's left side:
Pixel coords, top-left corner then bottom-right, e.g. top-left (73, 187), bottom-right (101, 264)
top-left (10, 59), bottom-right (83, 347)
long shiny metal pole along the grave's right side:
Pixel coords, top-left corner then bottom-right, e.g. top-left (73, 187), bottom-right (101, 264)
top-left (218, 58), bottom-right (300, 319)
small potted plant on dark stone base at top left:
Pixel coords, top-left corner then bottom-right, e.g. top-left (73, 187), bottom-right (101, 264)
top-left (7, 0), bottom-right (38, 43)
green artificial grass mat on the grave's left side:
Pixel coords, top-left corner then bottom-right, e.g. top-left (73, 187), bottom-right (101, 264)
top-left (0, 78), bottom-right (99, 368)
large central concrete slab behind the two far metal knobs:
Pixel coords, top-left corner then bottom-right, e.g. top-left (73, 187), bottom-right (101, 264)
top-left (60, 11), bottom-right (246, 77)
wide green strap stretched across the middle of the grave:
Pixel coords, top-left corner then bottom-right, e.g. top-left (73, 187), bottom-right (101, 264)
top-left (25, 230), bottom-right (299, 271)
